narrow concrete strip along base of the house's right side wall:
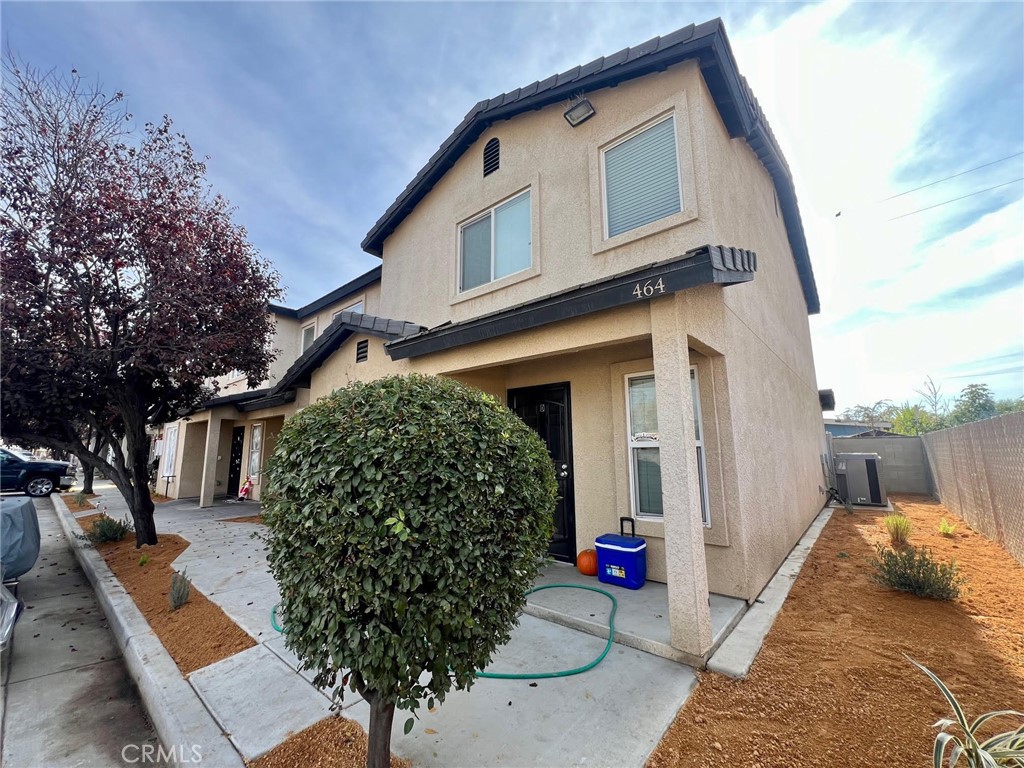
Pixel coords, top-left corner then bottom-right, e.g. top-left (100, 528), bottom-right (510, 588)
top-left (708, 507), bottom-right (833, 680)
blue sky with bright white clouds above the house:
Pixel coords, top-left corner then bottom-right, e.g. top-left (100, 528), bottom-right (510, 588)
top-left (0, 0), bottom-right (1024, 410)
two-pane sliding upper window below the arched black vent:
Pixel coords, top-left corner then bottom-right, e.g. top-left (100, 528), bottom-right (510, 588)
top-left (459, 189), bottom-right (532, 291)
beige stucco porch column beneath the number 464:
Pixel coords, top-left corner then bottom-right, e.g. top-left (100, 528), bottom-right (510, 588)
top-left (650, 295), bottom-right (712, 662)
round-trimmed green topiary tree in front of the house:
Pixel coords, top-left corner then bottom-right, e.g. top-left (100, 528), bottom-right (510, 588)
top-left (263, 375), bottom-right (557, 768)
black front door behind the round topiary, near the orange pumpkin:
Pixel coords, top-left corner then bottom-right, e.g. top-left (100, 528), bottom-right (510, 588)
top-left (508, 382), bottom-right (575, 563)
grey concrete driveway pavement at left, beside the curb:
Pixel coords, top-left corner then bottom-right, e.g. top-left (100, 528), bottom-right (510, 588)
top-left (0, 499), bottom-right (164, 768)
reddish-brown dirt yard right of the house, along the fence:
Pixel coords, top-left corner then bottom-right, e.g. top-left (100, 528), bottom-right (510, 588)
top-left (647, 496), bottom-right (1024, 768)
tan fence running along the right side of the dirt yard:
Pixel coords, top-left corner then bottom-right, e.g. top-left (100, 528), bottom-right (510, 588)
top-left (921, 413), bottom-right (1024, 563)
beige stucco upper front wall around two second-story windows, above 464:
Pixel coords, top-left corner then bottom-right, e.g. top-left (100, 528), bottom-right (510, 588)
top-left (381, 62), bottom-right (712, 327)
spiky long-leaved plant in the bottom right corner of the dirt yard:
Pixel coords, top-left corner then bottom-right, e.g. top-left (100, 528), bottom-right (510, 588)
top-left (907, 656), bottom-right (1024, 768)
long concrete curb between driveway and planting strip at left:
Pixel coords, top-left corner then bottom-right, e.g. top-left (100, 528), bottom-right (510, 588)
top-left (50, 494), bottom-right (245, 768)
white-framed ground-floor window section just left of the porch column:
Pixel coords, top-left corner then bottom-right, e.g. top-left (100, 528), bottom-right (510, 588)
top-left (626, 373), bottom-right (665, 518)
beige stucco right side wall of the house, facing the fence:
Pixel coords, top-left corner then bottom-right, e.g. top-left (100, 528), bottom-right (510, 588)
top-left (694, 78), bottom-right (825, 599)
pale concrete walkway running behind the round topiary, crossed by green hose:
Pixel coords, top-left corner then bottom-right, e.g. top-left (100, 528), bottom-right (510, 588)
top-left (58, 487), bottom-right (696, 768)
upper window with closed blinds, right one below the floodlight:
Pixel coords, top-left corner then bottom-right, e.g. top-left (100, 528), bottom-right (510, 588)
top-left (603, 117), bottom-right (682, 238)
